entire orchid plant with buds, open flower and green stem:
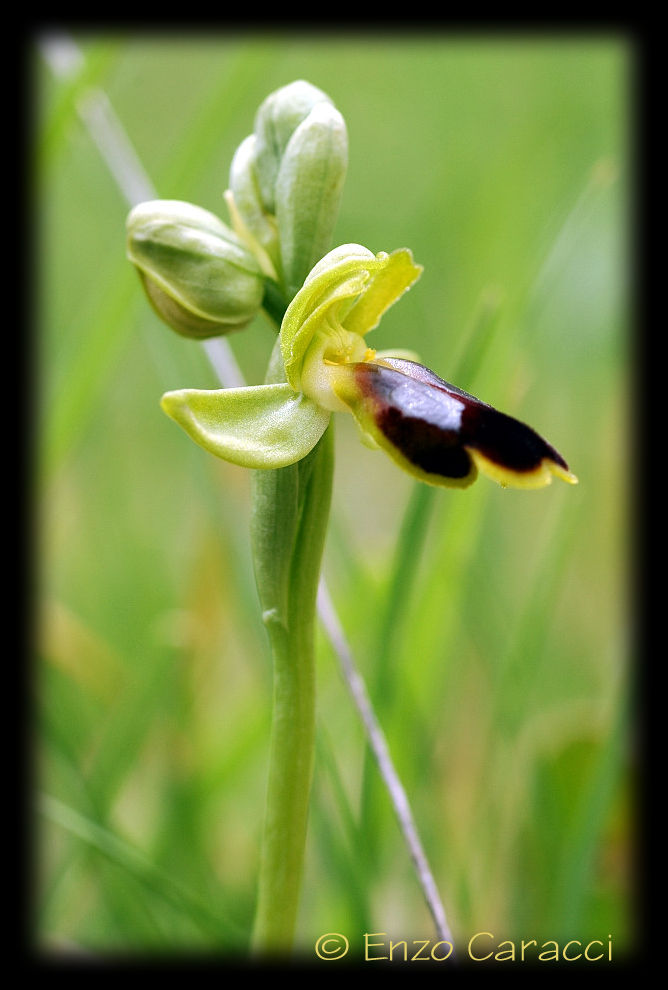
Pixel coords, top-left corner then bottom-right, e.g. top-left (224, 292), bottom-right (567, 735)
top-left (127, 80), bottom-right (577, 951)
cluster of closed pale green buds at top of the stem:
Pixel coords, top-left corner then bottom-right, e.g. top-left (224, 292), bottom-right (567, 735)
top-left (127, 81), bottom-right (347, 339)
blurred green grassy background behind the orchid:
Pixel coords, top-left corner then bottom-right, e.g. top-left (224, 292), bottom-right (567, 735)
top-left (31, 28), bottom-right (635, 957)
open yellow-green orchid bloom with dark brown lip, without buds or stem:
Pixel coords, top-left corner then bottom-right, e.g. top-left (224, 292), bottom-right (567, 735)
top-left (162, 244), bottom-right (577, 488)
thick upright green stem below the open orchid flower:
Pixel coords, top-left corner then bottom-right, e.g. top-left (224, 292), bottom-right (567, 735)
top-left (252, 427), bottom-right (333, 954)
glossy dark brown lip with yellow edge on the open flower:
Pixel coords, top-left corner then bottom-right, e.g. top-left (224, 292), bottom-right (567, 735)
top-left (337, 358), bottom-right (576, 488)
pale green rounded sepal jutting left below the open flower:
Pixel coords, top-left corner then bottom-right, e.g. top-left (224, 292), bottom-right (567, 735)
top-left (160, 384), bottom-right (330, 468)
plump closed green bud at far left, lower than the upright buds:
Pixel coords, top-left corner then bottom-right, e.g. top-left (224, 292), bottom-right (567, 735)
top-left (127, 200), bottom-right (264, 339)
